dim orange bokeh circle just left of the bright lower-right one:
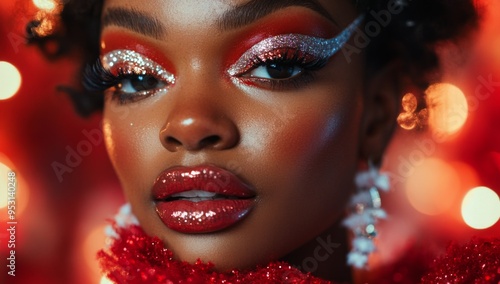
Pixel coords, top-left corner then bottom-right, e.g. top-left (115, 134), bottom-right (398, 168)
top-left (406, 158), bottom-right (460, 215)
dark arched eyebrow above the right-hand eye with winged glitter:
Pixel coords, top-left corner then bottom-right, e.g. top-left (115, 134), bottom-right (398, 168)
top-left (217, 0), bottom-right (336, 30)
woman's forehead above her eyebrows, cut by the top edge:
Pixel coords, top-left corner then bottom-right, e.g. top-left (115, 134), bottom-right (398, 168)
top-left (103, 0), bottom-right (357, 32)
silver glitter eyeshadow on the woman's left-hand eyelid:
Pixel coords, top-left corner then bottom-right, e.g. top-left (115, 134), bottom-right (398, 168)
top-left (102, 49), bottom-right (175, 85)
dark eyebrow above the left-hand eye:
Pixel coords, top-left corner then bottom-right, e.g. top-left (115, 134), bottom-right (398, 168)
top-left (101, 7), bottom-right (166, 39)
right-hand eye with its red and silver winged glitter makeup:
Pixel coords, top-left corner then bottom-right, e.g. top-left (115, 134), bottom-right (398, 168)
top-left (227, 15), bottom-right (364, 90)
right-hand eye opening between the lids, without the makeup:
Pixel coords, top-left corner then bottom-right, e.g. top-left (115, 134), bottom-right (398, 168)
top-left (242, 62), bottom-right (304, 80)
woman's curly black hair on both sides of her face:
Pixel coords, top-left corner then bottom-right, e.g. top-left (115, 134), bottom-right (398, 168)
top-left (26, 0), bottom-right (478, 117)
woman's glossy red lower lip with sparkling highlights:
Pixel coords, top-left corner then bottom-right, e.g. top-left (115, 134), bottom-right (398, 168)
top-left (156, 199), bottom-right (253, 233)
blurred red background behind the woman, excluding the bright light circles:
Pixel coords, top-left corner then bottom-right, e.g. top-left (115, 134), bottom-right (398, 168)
top-left (0, 0), bottom-right (500, 283)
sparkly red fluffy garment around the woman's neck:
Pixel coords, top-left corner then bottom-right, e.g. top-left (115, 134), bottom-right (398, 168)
top-left (98, 225), bottom-right (500, 284)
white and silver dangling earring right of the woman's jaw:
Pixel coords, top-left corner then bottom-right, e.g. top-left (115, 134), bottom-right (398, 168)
top-left (343, 161), bottom-right (389, 268)
